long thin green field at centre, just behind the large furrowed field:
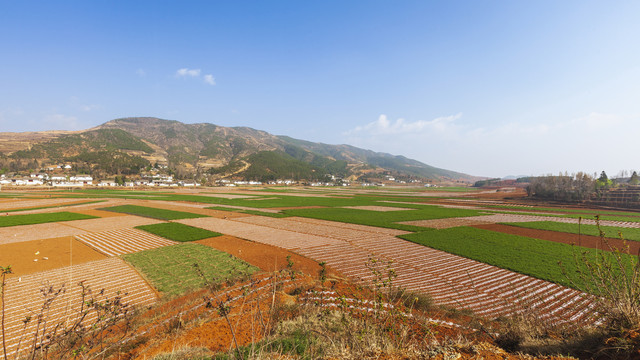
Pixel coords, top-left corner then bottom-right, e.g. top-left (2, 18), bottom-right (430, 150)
top-left (282, 204), bottom-right (483, 231)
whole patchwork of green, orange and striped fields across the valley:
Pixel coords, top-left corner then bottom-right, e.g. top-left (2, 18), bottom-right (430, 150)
top-left (0, 188), bottom-right (640, 358)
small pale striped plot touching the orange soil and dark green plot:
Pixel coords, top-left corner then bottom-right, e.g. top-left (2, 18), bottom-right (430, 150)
top-left (76, 229), bottom-right (176, 256)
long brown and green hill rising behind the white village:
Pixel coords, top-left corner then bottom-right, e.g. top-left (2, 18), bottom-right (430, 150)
top-left (0, 117), bottom-right (478, 181)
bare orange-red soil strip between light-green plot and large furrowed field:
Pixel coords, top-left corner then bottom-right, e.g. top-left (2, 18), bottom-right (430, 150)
top-left (196, 235), bottom-right (337, 275)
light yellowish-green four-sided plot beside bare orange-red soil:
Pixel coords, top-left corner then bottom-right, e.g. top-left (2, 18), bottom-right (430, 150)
top-left (122, 243), bottom-right (259, 296)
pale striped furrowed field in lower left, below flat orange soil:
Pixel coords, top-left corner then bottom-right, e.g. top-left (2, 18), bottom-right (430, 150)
top-left (0, 257), bottom-right (157, 354)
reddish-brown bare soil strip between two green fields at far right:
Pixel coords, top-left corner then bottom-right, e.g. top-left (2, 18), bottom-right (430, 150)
top-left (472, 224), bottom-right (640, 254)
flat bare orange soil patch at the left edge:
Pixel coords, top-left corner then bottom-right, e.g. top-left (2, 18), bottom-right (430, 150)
top-left (0, 236), bottom-right (106, 277)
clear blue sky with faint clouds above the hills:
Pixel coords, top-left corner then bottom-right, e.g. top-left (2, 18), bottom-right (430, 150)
top-left (0, 0), bottom-right (640, 176)
